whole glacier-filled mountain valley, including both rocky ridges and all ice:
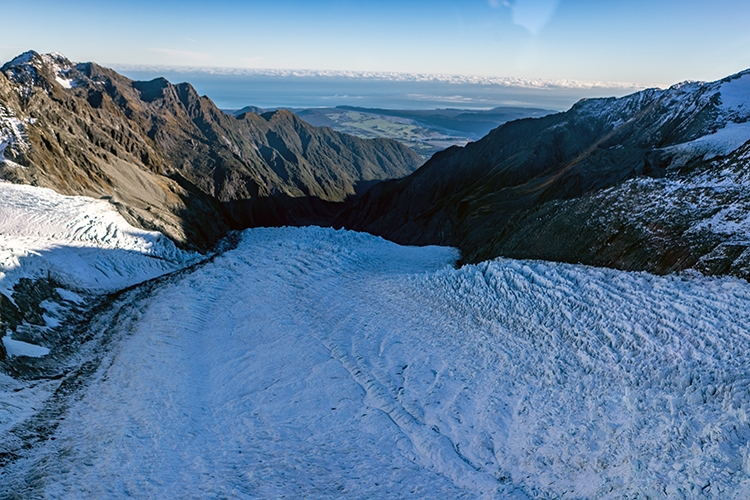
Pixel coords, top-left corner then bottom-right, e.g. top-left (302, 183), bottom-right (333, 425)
top-left (0, 52), bottom-right (750, 500)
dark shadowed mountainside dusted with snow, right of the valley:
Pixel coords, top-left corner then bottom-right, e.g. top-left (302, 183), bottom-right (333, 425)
top-left (337, 73), bottom-right (750, 275)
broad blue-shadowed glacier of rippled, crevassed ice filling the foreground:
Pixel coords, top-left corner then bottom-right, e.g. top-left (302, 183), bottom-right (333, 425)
top-left (0, 228), bottom-right (750, 498)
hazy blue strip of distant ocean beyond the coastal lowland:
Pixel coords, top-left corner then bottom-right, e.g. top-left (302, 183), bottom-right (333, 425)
top-left (114, 69), bottom-right (635, 110)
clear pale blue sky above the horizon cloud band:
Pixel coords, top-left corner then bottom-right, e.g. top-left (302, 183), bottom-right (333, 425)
top-left (0, 0), bottom-right (750, 85)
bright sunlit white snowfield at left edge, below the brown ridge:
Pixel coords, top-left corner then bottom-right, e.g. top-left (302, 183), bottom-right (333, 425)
top-left (0, 182), bottom-right (199, 297)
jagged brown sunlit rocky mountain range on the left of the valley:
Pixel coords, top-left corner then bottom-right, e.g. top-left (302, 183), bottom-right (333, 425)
top-left (0, 52), bottom-right (421, 250)
